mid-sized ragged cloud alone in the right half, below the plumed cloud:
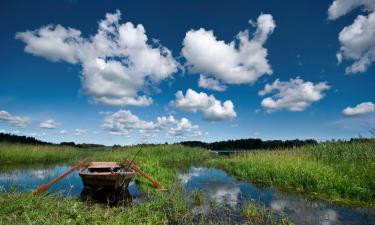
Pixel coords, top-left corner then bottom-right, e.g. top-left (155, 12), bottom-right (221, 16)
top-left (259, 77), bottom-right (330, 111)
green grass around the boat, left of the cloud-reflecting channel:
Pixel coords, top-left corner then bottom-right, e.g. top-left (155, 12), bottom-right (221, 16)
top-left (0, 145), bottom-right (214, 224)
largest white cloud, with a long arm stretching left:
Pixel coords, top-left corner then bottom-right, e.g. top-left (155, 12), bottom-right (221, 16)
top-left (16, 10), bottom-right (179, 106)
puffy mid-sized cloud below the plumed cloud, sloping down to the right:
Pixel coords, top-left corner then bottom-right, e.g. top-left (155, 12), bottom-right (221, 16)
top-left (172, 89), bottom-right (237, 121)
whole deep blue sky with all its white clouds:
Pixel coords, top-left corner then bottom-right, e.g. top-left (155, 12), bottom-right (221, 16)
top-left (0, 0), bottom-right (375, 145)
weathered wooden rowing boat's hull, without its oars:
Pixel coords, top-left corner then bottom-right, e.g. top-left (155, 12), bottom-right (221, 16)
top-left (79, 162), bottom-right (135, 190)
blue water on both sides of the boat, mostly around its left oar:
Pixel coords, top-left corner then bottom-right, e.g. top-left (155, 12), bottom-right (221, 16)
top-left (0, 166), bottom-right (140, 196)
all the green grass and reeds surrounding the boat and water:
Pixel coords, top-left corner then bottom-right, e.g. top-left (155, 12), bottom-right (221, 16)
top-left (0, 142), bottom-right (375, 224)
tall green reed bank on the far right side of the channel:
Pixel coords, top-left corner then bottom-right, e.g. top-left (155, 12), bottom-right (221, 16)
top-left (208, 142), bottom-right (375, 207)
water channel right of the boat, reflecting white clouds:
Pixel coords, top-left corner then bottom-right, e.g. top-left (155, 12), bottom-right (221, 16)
top-left (179, 167), bottom-right (375, 225)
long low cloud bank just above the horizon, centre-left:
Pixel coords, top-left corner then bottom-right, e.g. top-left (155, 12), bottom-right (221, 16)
top-left (102, 110), bottom-right (203, 137)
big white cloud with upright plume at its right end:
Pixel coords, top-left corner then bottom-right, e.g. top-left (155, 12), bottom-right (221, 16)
top-left (182, 14), bottom-right (276, 84)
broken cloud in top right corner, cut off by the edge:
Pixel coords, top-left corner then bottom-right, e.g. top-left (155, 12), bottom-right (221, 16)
top-left (328, 0), bottom-right (375, 74)
